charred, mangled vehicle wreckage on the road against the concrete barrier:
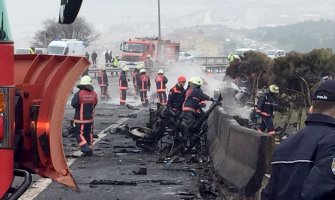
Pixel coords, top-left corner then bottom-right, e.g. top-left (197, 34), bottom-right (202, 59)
top-left (130, 95), bottom-right (222, 157)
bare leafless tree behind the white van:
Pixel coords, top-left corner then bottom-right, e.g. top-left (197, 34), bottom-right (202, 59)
top-left (31, 17), bottom-right (100, 47)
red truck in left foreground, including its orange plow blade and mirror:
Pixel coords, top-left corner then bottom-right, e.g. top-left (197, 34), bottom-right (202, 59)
top-left (0, 0), bottom-right (84, 199)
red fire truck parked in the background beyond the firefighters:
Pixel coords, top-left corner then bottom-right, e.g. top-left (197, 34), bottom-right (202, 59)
top-left (120, 37), bottom-right (180, 65)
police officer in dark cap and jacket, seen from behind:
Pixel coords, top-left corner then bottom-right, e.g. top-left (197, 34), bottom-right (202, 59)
top-left (262, 80), bottom-right (335, 200)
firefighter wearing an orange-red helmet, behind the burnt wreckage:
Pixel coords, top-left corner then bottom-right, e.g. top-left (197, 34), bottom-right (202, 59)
top-left (167, 76), bottom-right (186, 116)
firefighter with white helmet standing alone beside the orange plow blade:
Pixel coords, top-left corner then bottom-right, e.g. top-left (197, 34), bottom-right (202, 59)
top-left (71, 76), bottom-right (98, 156)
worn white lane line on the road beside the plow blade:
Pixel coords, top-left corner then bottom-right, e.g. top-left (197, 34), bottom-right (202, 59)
top-left (19, 115), bottom-right (133, 200)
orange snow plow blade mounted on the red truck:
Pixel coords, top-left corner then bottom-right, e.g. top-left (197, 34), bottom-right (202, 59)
top-left (14, 55), bottom-right (89, 191)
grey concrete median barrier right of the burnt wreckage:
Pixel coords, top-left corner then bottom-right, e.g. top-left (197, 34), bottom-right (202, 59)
top-left (208, 108), bottom-right (273, 197)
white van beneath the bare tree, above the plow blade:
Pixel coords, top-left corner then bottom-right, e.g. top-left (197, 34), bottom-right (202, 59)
top-left (48, 39), bottom-right (85, 56)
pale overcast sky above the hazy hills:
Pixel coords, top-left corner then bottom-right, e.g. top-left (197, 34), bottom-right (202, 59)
top-left (6, 0), bottom-right (335, 47)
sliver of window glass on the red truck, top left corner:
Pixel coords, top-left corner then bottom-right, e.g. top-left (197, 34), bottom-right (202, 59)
top-left (0, 0), bottom-right (12, 42)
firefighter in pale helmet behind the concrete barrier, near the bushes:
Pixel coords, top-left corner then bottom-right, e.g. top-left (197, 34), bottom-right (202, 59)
top-left (256, 85), bottom-right (279, 136)
